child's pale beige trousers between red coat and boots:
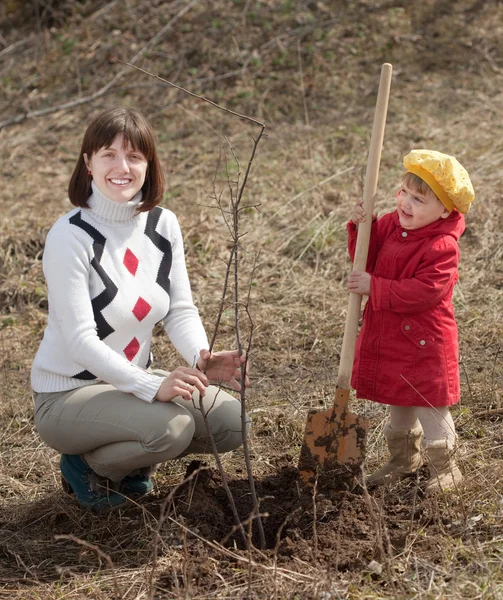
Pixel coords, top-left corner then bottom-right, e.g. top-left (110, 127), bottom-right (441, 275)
top-left (390, 406), bottom-right (456, 448)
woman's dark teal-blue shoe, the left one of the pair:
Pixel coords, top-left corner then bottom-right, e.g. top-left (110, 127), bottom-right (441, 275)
top-left (60, 454), bottom-right (127, 512)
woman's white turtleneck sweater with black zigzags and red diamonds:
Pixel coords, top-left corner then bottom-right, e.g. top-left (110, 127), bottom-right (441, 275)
top-left (31, 183), bottom-right (208, 402)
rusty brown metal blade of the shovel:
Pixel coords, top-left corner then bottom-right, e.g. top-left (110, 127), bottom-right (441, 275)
top-left (299, 388), bottom-right (368, 488)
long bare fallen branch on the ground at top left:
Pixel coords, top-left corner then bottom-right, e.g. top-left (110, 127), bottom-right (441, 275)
top-left (0, 0), bottom-right (199, 129)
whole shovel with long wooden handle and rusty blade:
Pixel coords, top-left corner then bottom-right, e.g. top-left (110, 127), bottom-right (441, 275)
top-left (299, 63), bottom-right (392, 487)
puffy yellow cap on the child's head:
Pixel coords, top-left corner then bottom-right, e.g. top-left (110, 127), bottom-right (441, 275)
top-left (403, 150), bottom-right (475, 214)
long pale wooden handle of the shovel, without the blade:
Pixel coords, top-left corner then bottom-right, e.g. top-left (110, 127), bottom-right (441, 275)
top-left (337, 63), bottom-right (393, 389)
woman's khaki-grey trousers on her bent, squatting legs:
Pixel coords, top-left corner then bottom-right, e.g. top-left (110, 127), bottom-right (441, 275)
top-left (34, 371), bottom-right (250, 481)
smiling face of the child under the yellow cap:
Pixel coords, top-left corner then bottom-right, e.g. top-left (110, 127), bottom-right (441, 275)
top-left (396, 181), bottom-right (450, 229)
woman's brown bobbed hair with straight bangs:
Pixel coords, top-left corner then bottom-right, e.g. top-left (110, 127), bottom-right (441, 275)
top-left (68, 107), bottom-right (166, 212)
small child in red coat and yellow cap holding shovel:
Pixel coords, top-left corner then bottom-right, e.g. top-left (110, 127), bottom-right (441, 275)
top-left (347, 150), bottom-right (474, 492)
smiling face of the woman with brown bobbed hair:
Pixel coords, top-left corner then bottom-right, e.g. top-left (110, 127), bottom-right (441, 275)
top-left (84, 134), bottom-right (148, 202)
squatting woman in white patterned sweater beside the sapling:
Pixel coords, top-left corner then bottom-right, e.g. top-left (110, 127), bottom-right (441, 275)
top-left (31, 108), bottom-right (250, 510)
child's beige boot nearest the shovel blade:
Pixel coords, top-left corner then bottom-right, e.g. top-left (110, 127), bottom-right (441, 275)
top-left (367, 424), bottom-right (423, 486)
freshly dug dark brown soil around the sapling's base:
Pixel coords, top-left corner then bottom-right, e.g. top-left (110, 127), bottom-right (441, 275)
top-left (175, 457), bottom-right (402, 570)
